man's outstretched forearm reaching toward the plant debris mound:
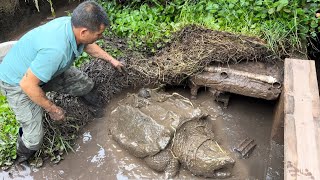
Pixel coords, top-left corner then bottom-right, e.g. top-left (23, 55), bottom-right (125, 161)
top-left (84, 43), bottom-right (123, 72)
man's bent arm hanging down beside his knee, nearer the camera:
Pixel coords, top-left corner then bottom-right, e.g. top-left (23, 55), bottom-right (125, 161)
top-left (20, 68), bottom-right (64, 120)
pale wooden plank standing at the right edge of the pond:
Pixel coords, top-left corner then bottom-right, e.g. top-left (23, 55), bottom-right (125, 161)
top-left (284, 59), bottom-right (320, 180)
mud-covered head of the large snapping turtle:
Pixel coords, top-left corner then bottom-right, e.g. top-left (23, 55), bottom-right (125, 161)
top-left (172, 116), bottom-right (234, 178)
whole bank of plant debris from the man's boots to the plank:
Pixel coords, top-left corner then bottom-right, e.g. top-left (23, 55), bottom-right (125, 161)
top-left (38, 26), bottom-right (278, 166)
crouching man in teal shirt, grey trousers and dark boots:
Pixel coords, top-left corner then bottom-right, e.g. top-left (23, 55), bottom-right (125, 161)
top-left (0, 1), bottom-right (123, 163)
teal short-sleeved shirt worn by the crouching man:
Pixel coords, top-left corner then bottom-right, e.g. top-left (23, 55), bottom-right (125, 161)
top-left (0, 17), bottom-right (84, 85)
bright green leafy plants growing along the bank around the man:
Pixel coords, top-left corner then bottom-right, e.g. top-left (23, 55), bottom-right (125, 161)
top-left (0, 0), bottom-right (320, 166)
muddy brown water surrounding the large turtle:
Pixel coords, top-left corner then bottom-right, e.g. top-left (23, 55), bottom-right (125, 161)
top-left (0, 89), bottom-right (282, 180)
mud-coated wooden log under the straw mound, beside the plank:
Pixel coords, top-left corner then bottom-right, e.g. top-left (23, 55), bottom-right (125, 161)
top-left (189, 62), bottom-right (282, 100)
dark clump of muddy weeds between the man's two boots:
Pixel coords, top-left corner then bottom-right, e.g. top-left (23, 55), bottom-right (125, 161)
top-left (30, 92), bottom-right (93, 167)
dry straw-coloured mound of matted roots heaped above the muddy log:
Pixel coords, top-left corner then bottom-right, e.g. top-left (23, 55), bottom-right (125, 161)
top-left (130, 26), bottom-right (278, 85)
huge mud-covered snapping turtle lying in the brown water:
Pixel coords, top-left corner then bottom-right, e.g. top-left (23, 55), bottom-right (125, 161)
top-left (110, 89), bottom-right (234, 178)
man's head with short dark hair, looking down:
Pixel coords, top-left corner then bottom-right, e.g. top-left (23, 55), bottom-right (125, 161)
top-left (71, 1), bottom-right (109, 44)
